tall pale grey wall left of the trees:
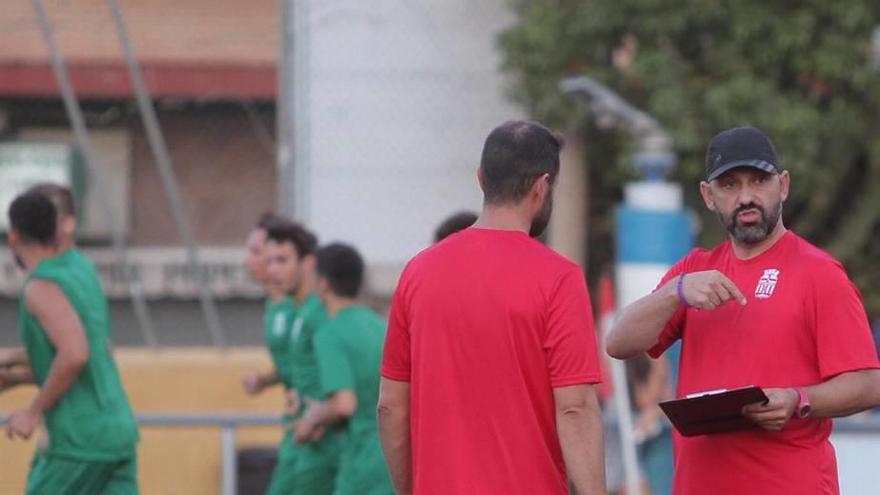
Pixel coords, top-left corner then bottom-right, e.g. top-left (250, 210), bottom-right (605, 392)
top-left (292, 0), bottom-right (522, 292)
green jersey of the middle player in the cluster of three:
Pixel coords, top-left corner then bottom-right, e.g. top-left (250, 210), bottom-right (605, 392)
top-left (287, 293), bottom-right (329, 412)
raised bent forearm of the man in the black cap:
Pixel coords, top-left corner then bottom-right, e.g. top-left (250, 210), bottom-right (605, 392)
top-left (605, 279), bottom-right (681, 359)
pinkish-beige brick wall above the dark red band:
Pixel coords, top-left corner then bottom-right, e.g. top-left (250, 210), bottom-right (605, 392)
top-left (0, 0), bottom-right (278, 64)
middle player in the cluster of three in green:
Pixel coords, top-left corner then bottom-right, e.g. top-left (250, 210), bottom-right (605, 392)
top-left (266, 222), bottom-right (340, 495)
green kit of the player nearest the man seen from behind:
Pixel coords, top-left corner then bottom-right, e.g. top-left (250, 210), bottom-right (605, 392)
top-left (315, 306), bottom-right (392, 495)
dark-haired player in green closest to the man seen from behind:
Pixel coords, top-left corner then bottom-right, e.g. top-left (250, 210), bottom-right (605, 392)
top-left (294, 244), bottom-right (394, 495)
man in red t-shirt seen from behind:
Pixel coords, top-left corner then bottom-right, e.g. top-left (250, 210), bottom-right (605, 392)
top-left (379, 121), bottom-right (605, 495)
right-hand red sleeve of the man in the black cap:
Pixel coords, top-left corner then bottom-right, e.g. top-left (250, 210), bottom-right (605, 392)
top-left (812, 263), bottom-right (880, 380)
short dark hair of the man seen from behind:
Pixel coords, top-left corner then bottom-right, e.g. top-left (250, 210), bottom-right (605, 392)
top-left (480, 120), bottom-right (563, 204)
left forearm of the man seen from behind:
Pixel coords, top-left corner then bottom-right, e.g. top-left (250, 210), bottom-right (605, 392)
top-left (378, 405), bottom-right (412, 495)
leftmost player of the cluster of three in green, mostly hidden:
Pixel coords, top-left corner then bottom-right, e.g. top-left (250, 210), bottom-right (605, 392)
top-left (242, 213), bottom-right (296, 493)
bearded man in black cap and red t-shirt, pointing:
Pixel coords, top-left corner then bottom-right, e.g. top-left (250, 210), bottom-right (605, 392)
top-left (607, 127), bottom-right (880, 495)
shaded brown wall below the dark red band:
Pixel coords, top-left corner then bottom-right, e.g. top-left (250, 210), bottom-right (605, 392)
top-left (131, 104), bottom-right (278, 246)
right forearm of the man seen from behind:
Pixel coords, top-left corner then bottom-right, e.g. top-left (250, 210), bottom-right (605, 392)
top-left (556, 403), bottom-right (605, 495)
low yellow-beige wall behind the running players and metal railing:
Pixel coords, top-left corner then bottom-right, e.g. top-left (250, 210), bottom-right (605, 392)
top-left (0, 348), bottom-right (292, 495)
